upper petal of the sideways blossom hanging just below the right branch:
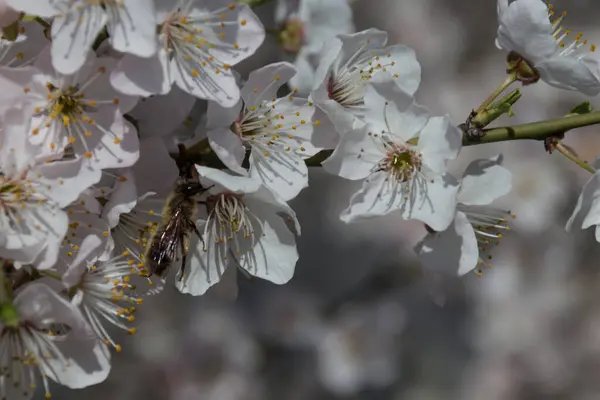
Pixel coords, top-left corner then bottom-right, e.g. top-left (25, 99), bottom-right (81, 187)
top-left (458, 155), bottom-right (512, 206)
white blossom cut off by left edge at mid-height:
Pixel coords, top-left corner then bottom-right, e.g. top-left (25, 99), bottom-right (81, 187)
top-left (0, 109), bottom-right (96, 269)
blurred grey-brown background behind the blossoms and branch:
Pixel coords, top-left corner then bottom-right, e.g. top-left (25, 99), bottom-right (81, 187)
top-left (47, 0), bottom-right (600, 400)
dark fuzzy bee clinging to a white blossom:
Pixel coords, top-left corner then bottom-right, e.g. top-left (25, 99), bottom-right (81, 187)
top-left (142, 145), bottom-right (210, 280)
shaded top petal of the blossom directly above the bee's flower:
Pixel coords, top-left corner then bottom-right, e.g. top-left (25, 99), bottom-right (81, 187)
top-left (240, 62), bottom-right (297, 108)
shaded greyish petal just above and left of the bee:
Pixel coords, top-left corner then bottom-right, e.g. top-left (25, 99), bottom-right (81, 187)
top-left (133, 137), bottom-right (179, 196)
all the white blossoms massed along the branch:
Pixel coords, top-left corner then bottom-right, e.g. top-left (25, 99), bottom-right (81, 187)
top-left (0, 0), bottom-right (600, 399)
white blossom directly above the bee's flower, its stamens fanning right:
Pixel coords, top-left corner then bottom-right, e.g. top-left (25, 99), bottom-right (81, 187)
top-left (207, 62), bottom-right (330, 201)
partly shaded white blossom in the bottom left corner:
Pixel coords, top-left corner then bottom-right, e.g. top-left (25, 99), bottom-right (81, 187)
top-left (0, 283), bottom-right (110, 399)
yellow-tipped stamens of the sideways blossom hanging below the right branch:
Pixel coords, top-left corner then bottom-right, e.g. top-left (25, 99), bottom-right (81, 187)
top-left (456, 204), bottom-right (516, 276)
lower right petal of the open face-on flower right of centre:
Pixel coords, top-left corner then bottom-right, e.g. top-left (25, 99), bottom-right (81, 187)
top-left (402, 175), bottom-right (459, 232)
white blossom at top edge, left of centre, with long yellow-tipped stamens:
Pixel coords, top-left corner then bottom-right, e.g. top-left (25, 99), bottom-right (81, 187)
top-left (111, 0), bottom-right (265, 107)
